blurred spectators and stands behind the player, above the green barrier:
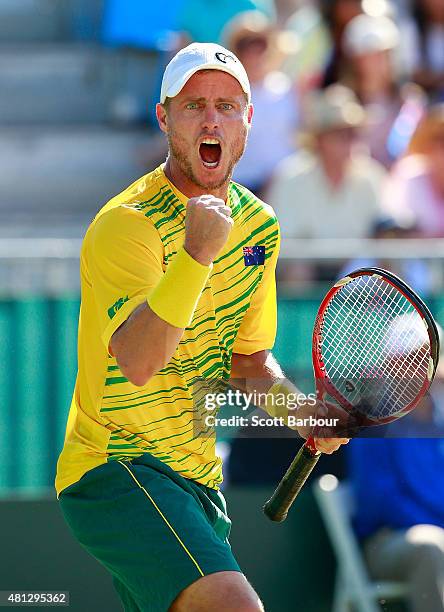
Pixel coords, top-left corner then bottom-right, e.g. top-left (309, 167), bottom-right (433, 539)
top-left (0, 0), bottom-right (444, 292)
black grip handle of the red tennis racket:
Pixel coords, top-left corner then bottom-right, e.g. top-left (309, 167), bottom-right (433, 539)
top-left (264, 444), bottom-right (321, 523)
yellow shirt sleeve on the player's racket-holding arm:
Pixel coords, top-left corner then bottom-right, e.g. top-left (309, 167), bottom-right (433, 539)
top-left (233, 221), bottom-right (280, 355)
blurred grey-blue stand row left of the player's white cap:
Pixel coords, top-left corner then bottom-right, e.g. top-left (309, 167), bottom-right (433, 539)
top-left (0, 44), bottom-right (158, 126)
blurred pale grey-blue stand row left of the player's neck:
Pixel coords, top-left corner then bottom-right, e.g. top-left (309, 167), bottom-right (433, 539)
top-left (0, 127), bottom-right (161, 225)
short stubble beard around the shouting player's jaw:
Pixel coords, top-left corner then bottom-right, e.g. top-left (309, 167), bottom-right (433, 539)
top-left (168, 128), bottom-right (248, 189)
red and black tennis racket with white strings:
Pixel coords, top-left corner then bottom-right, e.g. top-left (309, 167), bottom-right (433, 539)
top-left (264, 268), bottom-right (439, 522)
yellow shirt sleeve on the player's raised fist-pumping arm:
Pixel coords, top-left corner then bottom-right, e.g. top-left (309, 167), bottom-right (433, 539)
top-left (85, 206), bottom-right (163, 350)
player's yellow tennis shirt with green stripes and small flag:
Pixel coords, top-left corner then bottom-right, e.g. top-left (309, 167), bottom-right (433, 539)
top-left (56, 166), bottom-right (279, 494)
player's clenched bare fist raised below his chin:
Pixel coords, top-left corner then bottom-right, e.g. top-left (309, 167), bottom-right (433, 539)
top-left (184, 195), bottom-right (233, 266)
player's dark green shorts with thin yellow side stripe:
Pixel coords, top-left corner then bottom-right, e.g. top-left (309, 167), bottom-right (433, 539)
top-left (59, 454), bottom-right (241, 612)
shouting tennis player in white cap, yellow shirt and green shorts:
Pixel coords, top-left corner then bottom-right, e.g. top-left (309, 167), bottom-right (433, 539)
top-left (56, 43), bottom-right (345, 612)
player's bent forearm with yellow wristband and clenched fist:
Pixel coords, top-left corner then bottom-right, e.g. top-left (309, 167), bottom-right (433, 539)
top-left (110, 195), bottom-right (233, 387)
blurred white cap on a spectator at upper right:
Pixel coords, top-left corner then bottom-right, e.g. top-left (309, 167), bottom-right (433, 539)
top-left (344, 14), bottom-right (399, 56)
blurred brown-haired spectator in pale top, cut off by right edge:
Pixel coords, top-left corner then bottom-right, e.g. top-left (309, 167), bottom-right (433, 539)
top-left (384, 104), bottom-right (444, 238)
